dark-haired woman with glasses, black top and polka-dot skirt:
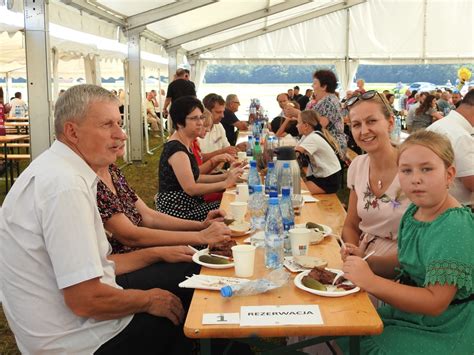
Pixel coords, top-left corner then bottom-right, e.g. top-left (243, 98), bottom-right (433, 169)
top-left (155, 96), bottom-right (243, 221)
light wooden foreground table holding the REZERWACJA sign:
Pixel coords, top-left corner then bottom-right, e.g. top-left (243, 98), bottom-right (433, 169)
top-left (184, 188), bottom-right (383, 354)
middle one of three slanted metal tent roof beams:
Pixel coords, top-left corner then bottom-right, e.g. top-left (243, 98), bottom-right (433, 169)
top-left (165, 0), bottom-right (311, 48)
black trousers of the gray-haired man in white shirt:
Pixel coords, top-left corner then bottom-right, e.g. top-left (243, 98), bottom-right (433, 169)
top-left (95, 263), bottom-right (200, 355)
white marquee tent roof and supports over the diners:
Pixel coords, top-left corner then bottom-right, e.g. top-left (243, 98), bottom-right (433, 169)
top-left (0, 0), bottom-right (474, 160)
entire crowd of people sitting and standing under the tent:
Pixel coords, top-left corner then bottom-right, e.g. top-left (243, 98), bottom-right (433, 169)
top-left (0, 65), bottom-right (474, 354)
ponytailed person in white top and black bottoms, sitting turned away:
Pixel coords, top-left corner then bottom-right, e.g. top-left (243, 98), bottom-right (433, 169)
top-left (295, 110), bottom-right (341, 194)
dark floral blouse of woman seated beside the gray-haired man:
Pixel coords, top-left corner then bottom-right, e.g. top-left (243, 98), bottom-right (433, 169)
top-left (97, 164), bottom-right (142, 254)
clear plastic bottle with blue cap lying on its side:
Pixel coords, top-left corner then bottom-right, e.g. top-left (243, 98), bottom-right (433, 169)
top-left (221, 268), bottom-right (290, 297)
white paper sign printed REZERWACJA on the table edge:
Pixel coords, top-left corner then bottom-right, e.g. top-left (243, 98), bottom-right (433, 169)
top-left (240, 305), bottom-right (323, 326)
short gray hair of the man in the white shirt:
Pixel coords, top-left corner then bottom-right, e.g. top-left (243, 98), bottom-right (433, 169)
top-left (54, 84), bottom-right (120, 137)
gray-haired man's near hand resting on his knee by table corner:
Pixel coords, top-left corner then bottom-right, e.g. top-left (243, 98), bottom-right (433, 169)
top-left (147, 288), bottom-right (184, 325)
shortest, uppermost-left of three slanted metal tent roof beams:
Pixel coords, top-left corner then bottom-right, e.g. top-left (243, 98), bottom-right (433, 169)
top-left (125, 0), bottom-right (218, 31)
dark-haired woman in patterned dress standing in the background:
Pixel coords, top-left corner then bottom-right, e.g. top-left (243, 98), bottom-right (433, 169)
top-left (285, 70), bottom-right (347, 159)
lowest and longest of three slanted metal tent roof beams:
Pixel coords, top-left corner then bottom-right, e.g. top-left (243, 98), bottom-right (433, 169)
top-left (187, 0), bottom-right (367, 58)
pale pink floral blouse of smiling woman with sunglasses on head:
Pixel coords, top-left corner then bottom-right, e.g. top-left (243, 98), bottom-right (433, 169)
top-left (347, 154), bottom-right (410, 240)
